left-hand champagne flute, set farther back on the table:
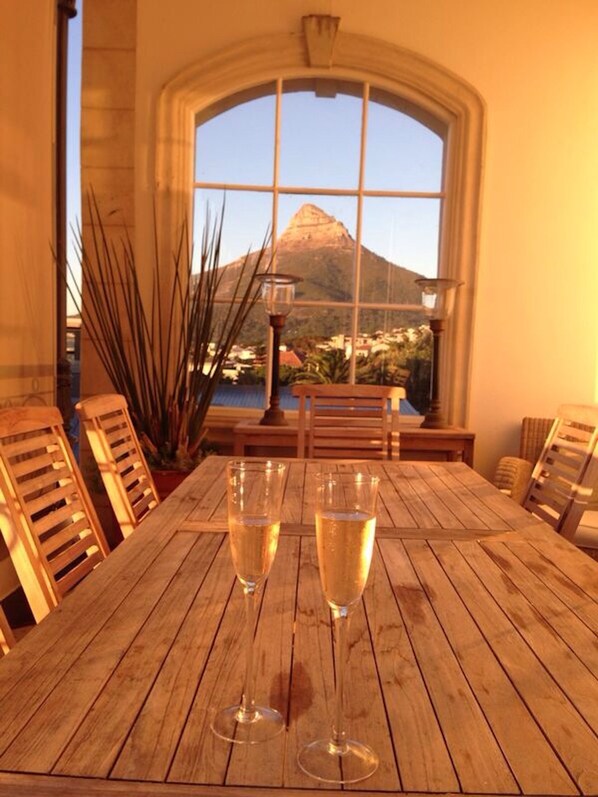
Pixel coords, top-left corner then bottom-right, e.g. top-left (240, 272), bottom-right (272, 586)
top-left (211, 460), bottom-right (286, 744)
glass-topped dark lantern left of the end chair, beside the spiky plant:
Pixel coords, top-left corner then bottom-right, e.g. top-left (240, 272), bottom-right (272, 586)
top-left (258, 274), bottom-right (301, 426)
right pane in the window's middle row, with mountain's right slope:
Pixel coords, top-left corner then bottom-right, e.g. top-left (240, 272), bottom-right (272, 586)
top-left (360, 197), bottom-right (440, 304)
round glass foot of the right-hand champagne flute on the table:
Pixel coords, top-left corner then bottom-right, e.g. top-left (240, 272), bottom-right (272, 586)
top-left (297, 739), bottom-right (378, 783)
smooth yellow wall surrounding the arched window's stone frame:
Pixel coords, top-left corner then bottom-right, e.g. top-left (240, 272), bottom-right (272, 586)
top-left (94, 0), bottom-right (598, 475)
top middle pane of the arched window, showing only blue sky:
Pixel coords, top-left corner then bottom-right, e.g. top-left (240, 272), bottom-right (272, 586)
top-left (279, 80), bottom-right (362, 188)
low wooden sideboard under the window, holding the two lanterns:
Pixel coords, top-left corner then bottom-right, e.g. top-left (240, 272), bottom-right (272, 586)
top-left (233, 421), bottom-right (475, 467)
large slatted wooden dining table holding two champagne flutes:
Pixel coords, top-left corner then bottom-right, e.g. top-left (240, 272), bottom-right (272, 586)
top-left (0, 457), bottom-right (598, 797)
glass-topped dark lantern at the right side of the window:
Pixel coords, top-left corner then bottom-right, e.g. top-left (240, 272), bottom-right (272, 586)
top-left (415, 278), bottom-right (463, 429)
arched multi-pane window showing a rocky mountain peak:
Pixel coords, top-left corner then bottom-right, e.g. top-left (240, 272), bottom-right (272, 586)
top-left (194, 78), bottom-right (446, 413)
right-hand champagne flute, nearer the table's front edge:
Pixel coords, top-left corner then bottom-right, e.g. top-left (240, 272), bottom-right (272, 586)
top-left (297, 472), bottom-right (379, 783)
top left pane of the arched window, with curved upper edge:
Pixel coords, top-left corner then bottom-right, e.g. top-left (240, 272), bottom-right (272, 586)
top-left (195, 84), bottom-right (276, 185)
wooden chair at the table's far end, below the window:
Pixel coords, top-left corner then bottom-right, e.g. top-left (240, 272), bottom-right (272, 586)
top-left (292, 385), bottom-right (405, 459)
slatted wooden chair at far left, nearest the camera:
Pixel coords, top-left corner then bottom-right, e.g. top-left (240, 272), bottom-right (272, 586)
top-left (0, 407), bottom-right (108, 622)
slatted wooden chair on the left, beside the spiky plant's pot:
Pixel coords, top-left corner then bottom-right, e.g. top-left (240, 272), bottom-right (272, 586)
top-left (76, 393), bottom-right (160, 537)
